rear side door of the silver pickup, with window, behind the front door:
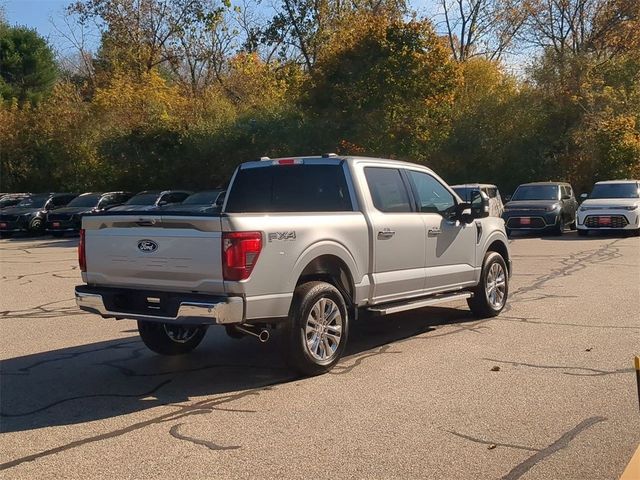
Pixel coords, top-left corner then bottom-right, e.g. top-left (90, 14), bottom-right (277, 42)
top-left (364, 167), bottom-right (426, 303)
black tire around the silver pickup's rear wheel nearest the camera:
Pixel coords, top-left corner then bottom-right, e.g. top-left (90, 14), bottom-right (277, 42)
top-left (284, 282), bottom-right (349, 376)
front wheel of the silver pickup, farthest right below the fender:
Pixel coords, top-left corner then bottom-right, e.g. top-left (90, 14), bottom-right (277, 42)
top-left (467, 252), bottom-right (509, 318)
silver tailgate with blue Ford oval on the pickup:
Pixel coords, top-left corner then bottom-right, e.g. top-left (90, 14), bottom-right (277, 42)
top-left (82, 215), bottom-right (224, 293)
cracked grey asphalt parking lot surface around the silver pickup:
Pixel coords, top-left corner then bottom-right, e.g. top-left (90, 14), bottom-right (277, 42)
top-left (0, 232), bottom-right (640, 480)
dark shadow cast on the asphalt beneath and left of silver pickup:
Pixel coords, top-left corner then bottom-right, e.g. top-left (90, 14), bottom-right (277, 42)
top-left (0, 308), bottom-right (474, 432)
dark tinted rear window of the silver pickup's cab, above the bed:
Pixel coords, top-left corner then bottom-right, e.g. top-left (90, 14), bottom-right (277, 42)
top-left (225, 163), bottom-right (354, 213)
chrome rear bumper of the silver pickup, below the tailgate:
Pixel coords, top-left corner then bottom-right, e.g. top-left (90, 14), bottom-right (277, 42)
top-left (75, 285), bottom-right (244, 325)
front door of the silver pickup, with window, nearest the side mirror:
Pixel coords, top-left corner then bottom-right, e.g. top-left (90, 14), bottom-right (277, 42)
top-left (406, 169), bottom-right (478, 293)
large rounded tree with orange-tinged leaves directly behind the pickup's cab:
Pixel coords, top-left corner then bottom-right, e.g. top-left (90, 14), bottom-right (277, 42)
top-left (306, 14), bottom-right (458, 160)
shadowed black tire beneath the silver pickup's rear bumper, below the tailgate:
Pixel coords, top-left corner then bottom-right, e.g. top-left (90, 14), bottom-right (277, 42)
top-left (138, 320), bottom-right (207, 355)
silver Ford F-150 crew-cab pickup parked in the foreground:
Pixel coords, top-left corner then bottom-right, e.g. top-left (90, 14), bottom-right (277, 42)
top-left (75, 154), bottom-right (511, 375)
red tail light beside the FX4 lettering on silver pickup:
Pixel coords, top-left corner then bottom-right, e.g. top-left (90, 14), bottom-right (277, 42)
top-left (222, 232), bottom-right (262, 282)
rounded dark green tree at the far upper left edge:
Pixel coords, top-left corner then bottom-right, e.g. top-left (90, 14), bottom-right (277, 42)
top-left (0, 22), bottom-right (58, 104)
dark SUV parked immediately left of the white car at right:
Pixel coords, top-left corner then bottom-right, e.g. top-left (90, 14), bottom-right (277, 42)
top-left (502, 182), bottom-right (578, 235)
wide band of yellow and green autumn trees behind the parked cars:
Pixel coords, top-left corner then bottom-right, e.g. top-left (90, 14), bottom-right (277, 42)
top-left (0, 0), bottom-right (640, 192)
